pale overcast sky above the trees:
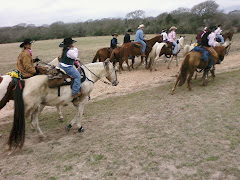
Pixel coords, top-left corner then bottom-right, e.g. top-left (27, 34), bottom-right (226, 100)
top-left (0, 0), bottom-right (240, 27)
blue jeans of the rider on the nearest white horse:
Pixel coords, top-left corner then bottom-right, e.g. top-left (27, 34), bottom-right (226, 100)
top-left (59, 64), bottom-right (81, 95)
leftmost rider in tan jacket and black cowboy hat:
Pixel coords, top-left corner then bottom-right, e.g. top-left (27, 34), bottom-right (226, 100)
top-left (16, 39), bottom-right (39, 78)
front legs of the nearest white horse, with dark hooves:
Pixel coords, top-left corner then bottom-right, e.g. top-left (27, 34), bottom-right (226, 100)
top-left (66, 96), bottom-right (87, 132)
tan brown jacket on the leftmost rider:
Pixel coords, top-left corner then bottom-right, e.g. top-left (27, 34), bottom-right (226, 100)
top-left (16, 49), bottom-right (36, 78)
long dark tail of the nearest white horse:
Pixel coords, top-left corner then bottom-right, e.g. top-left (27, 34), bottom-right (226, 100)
top-left (7, 80), bottom-right (25, 150)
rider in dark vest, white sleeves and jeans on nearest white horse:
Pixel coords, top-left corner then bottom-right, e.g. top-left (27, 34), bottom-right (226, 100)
top-left (59, 37), bottom-right (82, 99)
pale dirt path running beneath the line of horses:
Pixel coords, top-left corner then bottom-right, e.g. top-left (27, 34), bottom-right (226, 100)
top-left (0, 51), bottom-right (240, 121)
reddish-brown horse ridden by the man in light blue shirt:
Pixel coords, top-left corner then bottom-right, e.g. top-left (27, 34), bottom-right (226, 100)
top-left (119, 35), bottom-right (162, 72)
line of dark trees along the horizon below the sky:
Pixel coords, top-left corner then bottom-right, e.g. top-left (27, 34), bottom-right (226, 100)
top-left (0, 0), bottom-right (240, 44)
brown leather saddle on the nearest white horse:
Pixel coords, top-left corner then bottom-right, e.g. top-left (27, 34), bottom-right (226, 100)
top-left (47, 67), bottom-right (86, 88)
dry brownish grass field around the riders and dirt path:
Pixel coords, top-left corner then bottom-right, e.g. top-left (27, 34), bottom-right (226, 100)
top-left (0, 34), bottom-right (240, 180)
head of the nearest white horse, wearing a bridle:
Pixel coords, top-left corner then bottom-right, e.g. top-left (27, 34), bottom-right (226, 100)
top-left (104, 62), bottom-right (119, 86)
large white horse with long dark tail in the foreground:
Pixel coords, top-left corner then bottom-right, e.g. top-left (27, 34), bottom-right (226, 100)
top-left (8, 62), bottom-right (119, 149)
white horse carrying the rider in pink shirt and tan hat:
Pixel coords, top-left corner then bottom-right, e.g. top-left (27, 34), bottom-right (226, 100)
top-left (149, 36), bottom-right (184, 70)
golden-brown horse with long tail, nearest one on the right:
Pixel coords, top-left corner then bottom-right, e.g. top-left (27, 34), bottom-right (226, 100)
top-left (172, 46), bottom-right (230, 94)
